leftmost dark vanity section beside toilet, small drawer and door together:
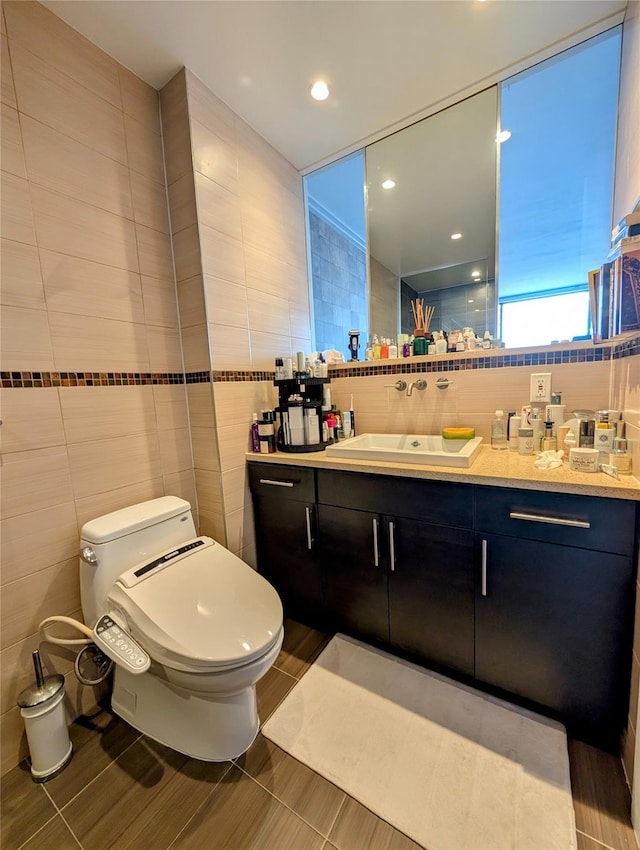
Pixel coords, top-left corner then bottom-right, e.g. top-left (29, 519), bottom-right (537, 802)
top-left (249, 463), bottom-right (323, 626)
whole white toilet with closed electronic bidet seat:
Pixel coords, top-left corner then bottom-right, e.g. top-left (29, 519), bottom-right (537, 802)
top-left (80, 496), bottom-right (284, 761)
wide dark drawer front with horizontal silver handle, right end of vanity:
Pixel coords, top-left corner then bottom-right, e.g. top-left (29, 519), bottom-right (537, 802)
top-left (476, 487), bottom-right (636, 555)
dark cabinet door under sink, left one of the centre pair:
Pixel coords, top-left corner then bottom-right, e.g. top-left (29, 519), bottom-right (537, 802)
top-left (318, 505), bottom-right (389, 643)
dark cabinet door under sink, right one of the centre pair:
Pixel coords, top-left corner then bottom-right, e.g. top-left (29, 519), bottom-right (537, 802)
top-left (385, 517), bottom-right (475, 675)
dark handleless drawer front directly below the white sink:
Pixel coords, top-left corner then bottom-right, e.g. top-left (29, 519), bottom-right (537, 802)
top-left (318, 469), bottom-right (473, 528)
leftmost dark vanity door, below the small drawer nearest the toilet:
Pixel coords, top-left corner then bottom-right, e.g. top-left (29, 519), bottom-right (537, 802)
top-left (253, 496), bottom-right (323, 626)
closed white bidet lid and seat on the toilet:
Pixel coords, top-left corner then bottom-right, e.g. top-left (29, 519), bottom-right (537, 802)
top-left (109, 537), bottom-right (283, 668)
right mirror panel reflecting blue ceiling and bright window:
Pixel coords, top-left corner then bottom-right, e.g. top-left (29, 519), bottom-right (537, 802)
top-left (498, 27), bottom-right (621, 347)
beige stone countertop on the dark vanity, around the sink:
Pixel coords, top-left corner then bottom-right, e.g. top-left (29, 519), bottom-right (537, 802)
top-left (246, 446), bottom-right (640, 502)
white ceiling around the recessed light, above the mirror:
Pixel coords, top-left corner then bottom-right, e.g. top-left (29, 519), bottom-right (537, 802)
top-left (44, 0), bottom-right (626, 172)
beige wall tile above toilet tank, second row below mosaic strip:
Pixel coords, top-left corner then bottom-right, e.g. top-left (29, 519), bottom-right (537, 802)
top-left (68, 432), bottom-right (162, 499)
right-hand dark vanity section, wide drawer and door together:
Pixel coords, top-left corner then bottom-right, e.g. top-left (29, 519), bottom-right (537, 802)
top-left (475, 488), bottom-right (635, 737)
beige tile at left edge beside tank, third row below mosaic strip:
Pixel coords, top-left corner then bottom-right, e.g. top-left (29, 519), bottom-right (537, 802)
top-left (0, 502), bottom-right (78, 584)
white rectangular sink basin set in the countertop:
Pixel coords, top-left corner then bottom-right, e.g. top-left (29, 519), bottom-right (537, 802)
top-left (326, 434), bottom-right (482, 468)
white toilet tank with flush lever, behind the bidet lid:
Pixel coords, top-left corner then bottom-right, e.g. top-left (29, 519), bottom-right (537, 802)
top-left (80, 496), bottom-right (196, 626)
